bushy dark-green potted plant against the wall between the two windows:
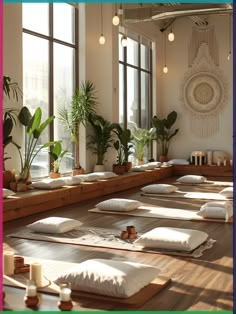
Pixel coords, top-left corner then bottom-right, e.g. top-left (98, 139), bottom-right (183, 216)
top-left (87, 114), bottom-right (114, 171)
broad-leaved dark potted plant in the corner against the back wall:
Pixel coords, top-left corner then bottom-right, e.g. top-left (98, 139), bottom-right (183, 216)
top-left (152, 111), bottom-right (179, 162)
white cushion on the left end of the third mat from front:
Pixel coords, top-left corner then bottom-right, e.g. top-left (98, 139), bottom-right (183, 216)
top-left (95, 198), bottom-right (143, 212)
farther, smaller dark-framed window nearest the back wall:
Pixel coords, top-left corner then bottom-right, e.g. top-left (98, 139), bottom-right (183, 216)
top-left (119, 34), bottom-right (152, 129)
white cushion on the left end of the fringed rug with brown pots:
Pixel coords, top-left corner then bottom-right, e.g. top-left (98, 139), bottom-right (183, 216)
top-left (27, 217), bottom-right (82, 233)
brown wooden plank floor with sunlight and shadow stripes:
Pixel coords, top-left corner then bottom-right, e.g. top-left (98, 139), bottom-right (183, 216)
top-left (4, 178), bottom-right (233, 311)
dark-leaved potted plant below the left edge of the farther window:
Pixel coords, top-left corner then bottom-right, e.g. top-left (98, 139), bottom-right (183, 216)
top-left (113, 123), bottom-right (133, 171)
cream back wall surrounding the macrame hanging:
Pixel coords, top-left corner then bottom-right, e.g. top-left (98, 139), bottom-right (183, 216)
top-left (157, 16), bottom-right (233, 158)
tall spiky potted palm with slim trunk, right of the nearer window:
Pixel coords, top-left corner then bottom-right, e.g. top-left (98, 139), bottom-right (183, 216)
top-left (58, 80), bottom-right (96, 174)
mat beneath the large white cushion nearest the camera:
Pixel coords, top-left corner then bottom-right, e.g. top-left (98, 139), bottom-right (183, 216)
top-left (3, 257), bottom-right (171, 306)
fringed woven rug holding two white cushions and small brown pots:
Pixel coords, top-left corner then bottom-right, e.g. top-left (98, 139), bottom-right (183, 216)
top-left (9, 226), bottom-right (215, 258)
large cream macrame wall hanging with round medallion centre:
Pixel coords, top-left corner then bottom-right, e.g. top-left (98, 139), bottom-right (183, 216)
top-left (180, 27), bottom-right (227, 137)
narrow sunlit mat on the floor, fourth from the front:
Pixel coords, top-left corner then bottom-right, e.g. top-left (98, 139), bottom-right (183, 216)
top-left (141, 191), bottom-right (232, 201)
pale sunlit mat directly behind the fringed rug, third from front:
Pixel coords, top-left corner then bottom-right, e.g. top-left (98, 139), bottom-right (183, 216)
top-left (88, 205), bottom-right (233, 223)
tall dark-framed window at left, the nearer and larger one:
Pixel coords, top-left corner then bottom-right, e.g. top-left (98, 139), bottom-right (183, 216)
top-left (22, 3), bottom-right (78, 177)
